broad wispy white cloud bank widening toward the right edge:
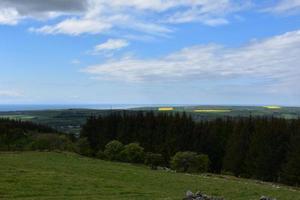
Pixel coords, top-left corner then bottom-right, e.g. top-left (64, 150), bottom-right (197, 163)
top-left (82, 30), bottom-right (300, 91)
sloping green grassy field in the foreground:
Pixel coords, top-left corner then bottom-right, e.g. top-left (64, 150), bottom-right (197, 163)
top-left (0, 152), bottom-right (300, 200)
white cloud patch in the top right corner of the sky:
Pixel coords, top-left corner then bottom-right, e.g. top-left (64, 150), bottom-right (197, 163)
top-left (264, 0), bottom-right (300, 14)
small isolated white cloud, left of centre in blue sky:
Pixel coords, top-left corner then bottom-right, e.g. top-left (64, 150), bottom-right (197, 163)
top-left (94, 39), bottom-right (129, 52)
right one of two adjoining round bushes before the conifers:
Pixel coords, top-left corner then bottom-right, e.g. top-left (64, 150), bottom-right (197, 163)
top-left (121, 143), bottom-right (145, 163)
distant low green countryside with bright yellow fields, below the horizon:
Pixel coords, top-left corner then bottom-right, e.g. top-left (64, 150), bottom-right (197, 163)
top-left (0, 105), bottom-right (300, 134)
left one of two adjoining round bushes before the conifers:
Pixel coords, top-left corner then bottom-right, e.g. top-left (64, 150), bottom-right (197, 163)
top-left (104, 140), bottom-right (124, 161)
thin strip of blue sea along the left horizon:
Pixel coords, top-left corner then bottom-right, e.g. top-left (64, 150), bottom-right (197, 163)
top-left (0, 104), bottom-right (191, 112)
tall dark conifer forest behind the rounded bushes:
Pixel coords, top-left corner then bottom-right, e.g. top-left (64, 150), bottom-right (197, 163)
top-left (80, 111), bottom-right (300, 185)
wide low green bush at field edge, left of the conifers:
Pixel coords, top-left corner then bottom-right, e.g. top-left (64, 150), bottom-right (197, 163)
top-left (31, 134), bottom-right (73, 151)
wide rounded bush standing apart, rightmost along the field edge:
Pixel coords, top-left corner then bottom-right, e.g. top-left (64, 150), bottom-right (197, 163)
top-left (171, 151), bottom-right (210, 172)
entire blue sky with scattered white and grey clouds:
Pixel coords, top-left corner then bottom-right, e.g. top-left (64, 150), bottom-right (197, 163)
top-left (0, 0), bottom-right (300, 106)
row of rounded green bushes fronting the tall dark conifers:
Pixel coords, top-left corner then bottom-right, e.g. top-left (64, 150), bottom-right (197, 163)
top-left (77, 138), bottom-right (210, 173)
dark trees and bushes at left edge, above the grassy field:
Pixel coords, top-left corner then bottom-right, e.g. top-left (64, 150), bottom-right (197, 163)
top-left (0, 118), bottom-right (74, 151)
